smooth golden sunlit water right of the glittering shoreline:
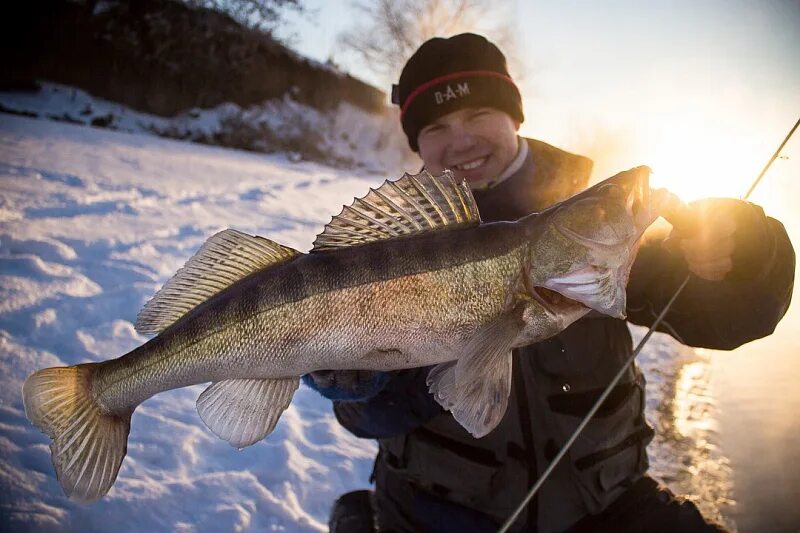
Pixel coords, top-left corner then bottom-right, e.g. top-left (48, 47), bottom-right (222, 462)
top-left (712, 318), bottom-right (800, 533)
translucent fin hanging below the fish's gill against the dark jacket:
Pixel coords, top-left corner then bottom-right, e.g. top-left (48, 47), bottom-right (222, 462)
top-left (428, 317), bottom-right (520, 438)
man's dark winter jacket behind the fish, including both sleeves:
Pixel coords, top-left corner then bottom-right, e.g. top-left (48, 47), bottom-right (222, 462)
top-left (326, 140), bottom-right (794, 532)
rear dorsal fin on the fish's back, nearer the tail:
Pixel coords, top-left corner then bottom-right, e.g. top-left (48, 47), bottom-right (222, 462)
top-left (135, 229), bottom-right (300, 334)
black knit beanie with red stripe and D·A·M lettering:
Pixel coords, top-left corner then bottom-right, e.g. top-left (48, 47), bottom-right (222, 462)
top-left (392, 33), bottom-right (525, 152)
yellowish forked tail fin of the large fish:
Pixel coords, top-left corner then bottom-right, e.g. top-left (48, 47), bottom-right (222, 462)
top-left (22, 364), bottom-right (132, 503)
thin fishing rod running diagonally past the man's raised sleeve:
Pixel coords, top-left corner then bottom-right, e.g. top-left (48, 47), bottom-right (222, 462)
top-left (499, 119), bottom-right (800, 533)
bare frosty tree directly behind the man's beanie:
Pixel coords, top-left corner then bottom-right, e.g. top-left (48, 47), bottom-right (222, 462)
top-left (338, 0), bottom-right (518, 86)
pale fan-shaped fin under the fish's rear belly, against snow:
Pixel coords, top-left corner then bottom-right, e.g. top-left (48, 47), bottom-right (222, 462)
top-left (197, 378), bottom-right (300, 449)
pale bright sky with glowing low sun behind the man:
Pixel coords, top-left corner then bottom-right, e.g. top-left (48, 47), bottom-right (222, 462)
top-left (276, 0), bottom-right (800, 200)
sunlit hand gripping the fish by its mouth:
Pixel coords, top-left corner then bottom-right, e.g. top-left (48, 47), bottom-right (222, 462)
top-left (664, 198), bottom-right (771, 281)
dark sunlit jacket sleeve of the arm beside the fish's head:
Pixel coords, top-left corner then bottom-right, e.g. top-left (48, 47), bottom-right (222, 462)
top-left (627, 214), bottom-right (795, 350)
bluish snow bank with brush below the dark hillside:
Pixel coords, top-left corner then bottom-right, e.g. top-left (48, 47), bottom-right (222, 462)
top-left (0, 82), bottom-right (420, 172)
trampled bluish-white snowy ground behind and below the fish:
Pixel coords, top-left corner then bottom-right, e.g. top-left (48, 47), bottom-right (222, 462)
top-left (0, 115), bottom-right (725, 532)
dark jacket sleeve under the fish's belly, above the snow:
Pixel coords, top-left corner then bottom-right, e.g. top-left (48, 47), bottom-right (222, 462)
top-left (333, 367), bottom-right (443, 439)
